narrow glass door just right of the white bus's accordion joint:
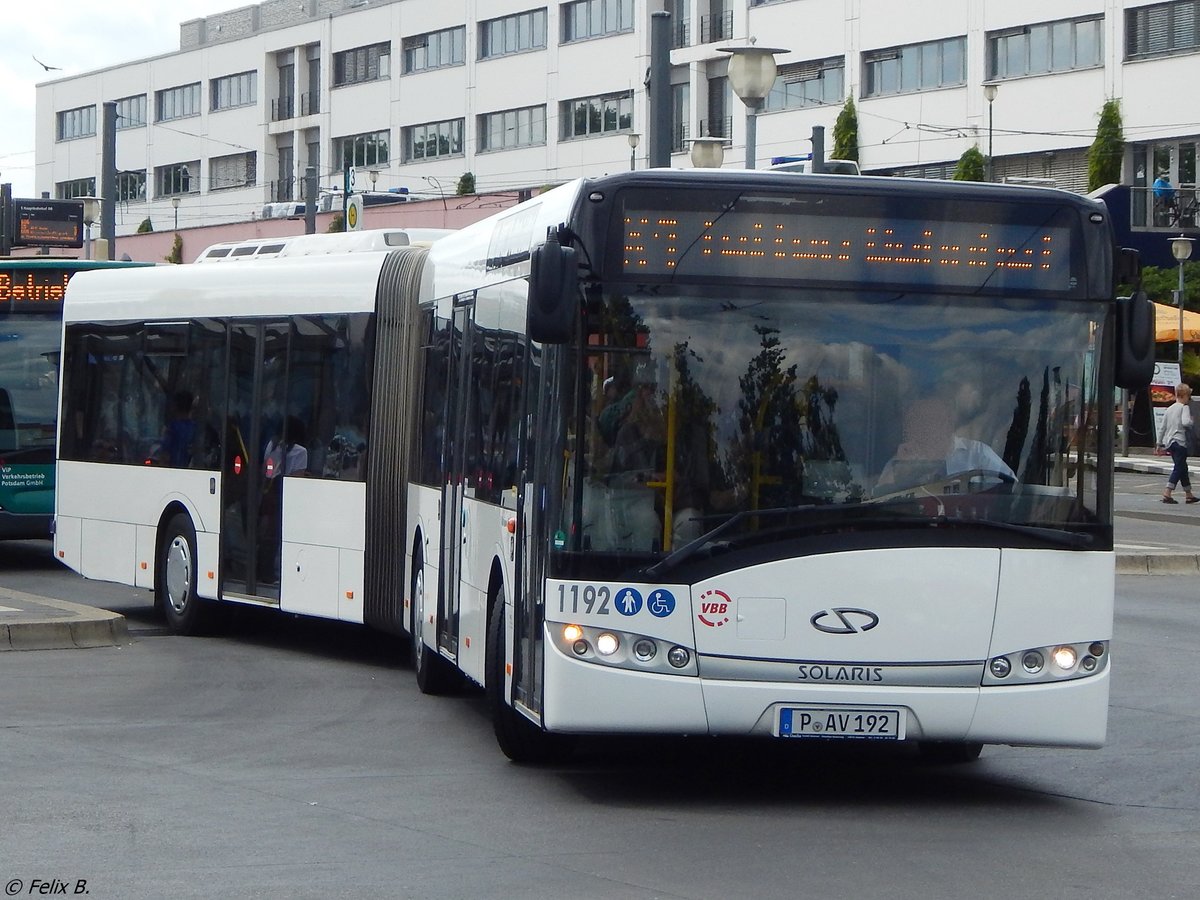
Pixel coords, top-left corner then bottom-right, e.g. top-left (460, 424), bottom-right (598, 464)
top-left (437, 294), bottom-right (475, 659)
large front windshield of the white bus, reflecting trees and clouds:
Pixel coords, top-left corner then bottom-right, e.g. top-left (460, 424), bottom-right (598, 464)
top-left (556, 286), bottom-right (1111, 573)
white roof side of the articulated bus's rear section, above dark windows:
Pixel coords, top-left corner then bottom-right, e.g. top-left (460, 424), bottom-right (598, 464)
top-left (64, 253), bottom-right (388, 322)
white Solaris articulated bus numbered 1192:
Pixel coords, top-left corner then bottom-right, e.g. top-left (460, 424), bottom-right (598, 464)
top-left (55, 170), bottom-right (1153, 760)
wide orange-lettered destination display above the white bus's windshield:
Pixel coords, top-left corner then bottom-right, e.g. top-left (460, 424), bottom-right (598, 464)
top-left (620, 208), bottom-right (1075, 293)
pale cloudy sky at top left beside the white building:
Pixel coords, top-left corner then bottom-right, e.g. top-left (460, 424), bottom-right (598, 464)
top-left (0, 0), bottom-right (236, 197)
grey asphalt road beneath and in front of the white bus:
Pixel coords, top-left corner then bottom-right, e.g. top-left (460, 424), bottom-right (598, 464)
top-left (0, 518), bottom-right (1200, 900)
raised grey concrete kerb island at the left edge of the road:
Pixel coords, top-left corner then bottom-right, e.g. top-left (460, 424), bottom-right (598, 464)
top-left (0, 589), bottom-right (131, 652)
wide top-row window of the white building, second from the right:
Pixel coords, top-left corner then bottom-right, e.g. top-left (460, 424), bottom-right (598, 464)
top-left (988, 16), bottom-right (1104, 79)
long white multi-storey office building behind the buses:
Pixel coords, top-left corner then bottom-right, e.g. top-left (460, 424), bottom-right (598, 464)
top-left (36, 0), bottom-right (1200, 247)
